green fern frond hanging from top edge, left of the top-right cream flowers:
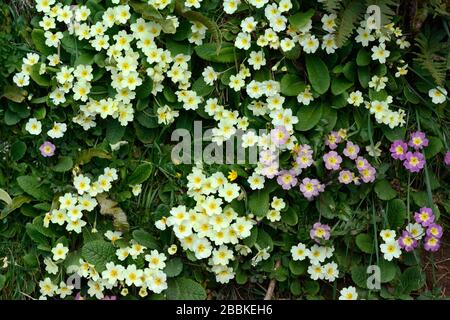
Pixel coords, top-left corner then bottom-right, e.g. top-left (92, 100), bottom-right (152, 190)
top-left (335, 0), bottom-right (365, 47)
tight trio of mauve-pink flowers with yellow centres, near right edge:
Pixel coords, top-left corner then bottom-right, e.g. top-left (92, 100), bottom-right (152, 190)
top-left (389, 131), bottom-right (428, 172)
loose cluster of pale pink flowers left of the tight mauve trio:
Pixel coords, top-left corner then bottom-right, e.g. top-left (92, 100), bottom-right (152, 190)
top-left (323, 131), bottom-right (376, 185)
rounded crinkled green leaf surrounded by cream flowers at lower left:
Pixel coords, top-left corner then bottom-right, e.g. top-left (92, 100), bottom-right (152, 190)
top-left (81, 240), bottom-right (116, 272)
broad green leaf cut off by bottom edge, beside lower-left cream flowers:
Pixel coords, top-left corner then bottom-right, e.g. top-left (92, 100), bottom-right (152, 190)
top-left (166, 278), bottom-right (206, 300)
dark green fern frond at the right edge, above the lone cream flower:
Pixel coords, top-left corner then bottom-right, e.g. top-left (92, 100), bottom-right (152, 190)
top-left (414, 33), bottom-right (449, 86)
